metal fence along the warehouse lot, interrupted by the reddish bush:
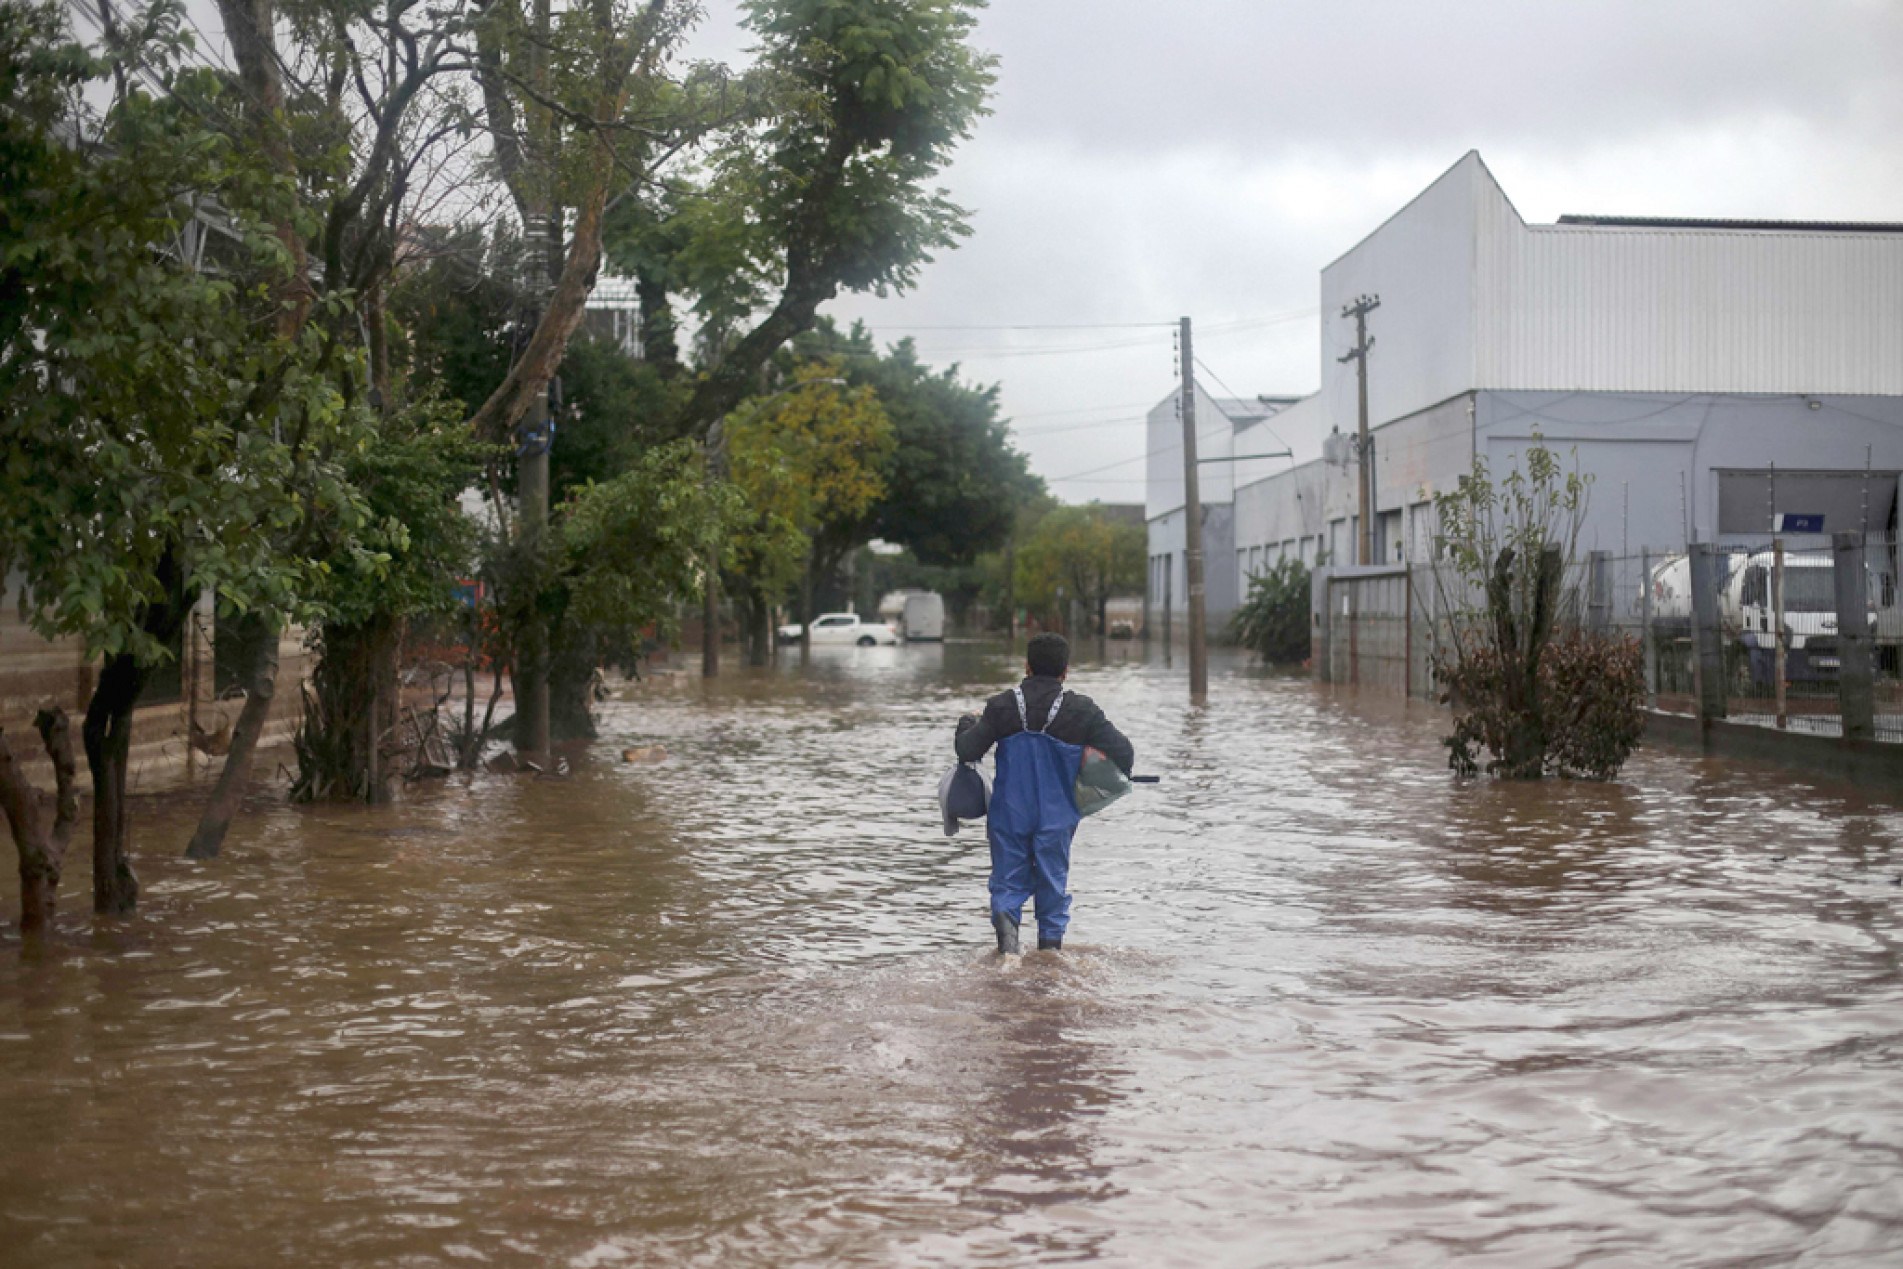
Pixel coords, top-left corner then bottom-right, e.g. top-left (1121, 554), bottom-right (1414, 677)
top-left (1315, 533), bottom-right (1903, 742)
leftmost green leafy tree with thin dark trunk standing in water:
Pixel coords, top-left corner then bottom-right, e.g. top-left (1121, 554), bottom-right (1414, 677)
top-left (0, 4), bottom-right (377, 913)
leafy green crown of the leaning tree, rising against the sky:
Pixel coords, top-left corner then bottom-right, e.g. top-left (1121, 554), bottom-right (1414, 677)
top-left (641, 0), bottom-right (993, 434)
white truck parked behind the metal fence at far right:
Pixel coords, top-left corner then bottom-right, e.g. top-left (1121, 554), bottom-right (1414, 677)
top-left (1648, 550), bottom-right (1895, 685)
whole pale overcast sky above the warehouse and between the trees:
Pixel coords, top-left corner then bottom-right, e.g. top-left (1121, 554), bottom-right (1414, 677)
top-left (696, 0), bottom-right (1903, 502)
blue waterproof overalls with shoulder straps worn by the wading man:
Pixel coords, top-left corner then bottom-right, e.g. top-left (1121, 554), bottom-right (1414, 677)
top-left (986, 687), bottom-right (1083, 942)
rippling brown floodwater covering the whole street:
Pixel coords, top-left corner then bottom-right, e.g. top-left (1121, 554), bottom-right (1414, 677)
top-left (0, 645), bottom-right (1903, 1267)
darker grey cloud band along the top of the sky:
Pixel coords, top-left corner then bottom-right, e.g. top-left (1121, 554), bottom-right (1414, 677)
top-left (980, 0), bottom-right (1903, 158)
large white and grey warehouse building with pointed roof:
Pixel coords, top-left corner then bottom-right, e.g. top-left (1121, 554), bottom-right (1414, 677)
top-left (1146, 152), bottom-right (1903, 628)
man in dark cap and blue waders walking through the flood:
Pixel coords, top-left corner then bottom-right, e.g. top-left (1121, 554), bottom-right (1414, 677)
top-left (952, 634), bottom-right (1136, 951)
